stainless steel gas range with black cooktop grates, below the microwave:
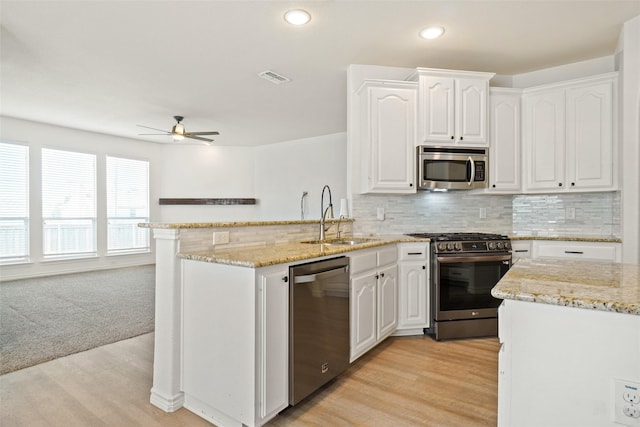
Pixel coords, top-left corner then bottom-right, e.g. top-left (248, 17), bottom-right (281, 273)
top-left (410, 233), bottom-right (511, 340)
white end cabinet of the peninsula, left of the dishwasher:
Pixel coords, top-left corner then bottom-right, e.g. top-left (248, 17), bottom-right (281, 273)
top-left (182, 260), bottom-right (289, 426)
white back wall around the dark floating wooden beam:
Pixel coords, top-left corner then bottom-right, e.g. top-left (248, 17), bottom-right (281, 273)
top-left (152, 143), bottom-right (257, 223)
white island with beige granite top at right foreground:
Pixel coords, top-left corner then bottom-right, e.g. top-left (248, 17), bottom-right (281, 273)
top-left (492, 258), bottom-right (640, 427)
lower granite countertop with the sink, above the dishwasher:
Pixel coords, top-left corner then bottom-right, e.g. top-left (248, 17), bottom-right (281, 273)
top-left (178, 236), bottom-right (429, 268)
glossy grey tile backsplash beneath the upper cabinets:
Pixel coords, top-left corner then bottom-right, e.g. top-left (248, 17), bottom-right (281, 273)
top-left (352, 191), bottom-right (621, 237)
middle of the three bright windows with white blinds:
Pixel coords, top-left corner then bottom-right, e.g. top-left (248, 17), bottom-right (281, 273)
top-left (42, 148), bottom-right (96, 257)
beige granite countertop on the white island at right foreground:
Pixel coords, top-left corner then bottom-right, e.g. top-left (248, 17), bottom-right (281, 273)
top-left (491, 259), bottom-right (640, 316)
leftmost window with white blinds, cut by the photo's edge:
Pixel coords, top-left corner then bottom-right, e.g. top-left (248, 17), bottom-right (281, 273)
top-left (0, 143), bottom-right (29, 262)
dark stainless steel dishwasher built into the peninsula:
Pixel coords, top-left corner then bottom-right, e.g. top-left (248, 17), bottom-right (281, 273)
top-left (289, 257), bottom-right (349, 405)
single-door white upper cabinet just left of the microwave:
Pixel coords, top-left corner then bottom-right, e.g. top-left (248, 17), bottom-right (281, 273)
top-left (354, 80), bottom-right (417, 194)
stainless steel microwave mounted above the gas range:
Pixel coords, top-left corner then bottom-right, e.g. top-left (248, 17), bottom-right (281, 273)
top-left (417, 145), bottom-right (489, 190)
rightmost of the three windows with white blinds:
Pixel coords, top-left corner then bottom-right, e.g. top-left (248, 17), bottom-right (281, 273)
top-left (107, 156), bottom-right (149, 254)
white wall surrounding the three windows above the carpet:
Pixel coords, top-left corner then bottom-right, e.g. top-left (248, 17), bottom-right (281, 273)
top-left (0, 117), bottom-right (161, 280)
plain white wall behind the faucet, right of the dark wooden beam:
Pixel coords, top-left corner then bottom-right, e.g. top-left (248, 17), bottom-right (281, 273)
top-left (254, 133), bottom-right (347, 220)
